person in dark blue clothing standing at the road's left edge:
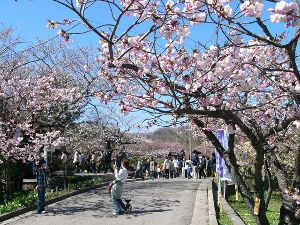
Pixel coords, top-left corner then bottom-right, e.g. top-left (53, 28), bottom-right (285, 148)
top-left (36, 158), bottom-right (47, 214)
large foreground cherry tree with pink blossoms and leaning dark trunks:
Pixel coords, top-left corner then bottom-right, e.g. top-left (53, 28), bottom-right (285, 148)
top-left (48, 0), bottom-right (300, 224)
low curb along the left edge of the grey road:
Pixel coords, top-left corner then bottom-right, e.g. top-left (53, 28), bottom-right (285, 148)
top-left (0, 178), bottom-right (142, 223)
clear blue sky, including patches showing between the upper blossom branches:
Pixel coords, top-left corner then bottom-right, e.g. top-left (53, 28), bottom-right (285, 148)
top-left (0, 0), bottom-right (292, 133)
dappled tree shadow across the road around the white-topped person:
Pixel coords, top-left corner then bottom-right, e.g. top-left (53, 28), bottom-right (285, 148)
top-left (41, 180), bottom-right (197, 218)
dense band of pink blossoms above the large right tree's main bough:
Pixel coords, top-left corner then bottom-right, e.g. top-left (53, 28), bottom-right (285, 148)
top-left (98, 28), bottom-right (300, 126)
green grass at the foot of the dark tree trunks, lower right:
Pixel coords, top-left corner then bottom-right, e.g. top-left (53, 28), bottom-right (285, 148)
top-left (228, 192), bottom-right (281, 225)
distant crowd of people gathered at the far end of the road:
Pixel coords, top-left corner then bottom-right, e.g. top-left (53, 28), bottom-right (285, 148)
top-left (69, 151), bottom-right (216, 182)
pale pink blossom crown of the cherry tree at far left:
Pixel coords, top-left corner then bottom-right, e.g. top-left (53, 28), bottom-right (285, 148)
top-left (0, 31), bottom-right (88, 158)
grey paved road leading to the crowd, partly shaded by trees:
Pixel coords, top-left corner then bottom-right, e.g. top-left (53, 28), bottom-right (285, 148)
top-left (3, 178), bottom-right (209, 225)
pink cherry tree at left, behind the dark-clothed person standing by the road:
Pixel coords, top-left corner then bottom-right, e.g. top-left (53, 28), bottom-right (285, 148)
top-left (0, 29), bottom-right (101, 198)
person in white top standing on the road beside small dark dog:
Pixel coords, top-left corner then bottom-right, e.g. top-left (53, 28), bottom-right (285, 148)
top-left (111, 160), bottom-right (129, 215)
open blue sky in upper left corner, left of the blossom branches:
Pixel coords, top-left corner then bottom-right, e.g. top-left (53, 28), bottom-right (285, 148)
top-left (0, 0), bottom-right (97, 45)
